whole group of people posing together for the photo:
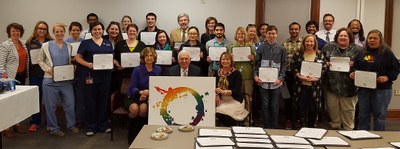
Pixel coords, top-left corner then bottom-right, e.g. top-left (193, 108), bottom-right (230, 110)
top-left (0, 13), bottom-right (400, 142)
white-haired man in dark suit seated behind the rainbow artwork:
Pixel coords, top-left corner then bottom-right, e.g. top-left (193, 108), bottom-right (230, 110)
top-left (168, 50), bottom-right (201, 76)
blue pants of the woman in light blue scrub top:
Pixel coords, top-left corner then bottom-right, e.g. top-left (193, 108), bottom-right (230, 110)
top-left (42, 83), bottom-right (75, 134)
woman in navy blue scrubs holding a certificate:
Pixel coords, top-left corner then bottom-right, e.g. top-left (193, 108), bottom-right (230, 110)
top-left (75, 22), bottom-right (113, 136)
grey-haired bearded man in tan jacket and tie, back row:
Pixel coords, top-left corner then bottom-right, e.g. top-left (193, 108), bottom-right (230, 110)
top-left (170, 13), bottom-right (190, 50)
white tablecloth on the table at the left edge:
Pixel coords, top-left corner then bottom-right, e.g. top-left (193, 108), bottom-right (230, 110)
top-left (0, 86), bottom-right (39, 131)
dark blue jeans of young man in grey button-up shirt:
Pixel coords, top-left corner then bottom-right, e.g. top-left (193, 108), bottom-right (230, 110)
top-left (260, 87), bottom-right (281, 128)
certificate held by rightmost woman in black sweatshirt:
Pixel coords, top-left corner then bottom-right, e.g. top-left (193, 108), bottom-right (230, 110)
top-left (354, 70), bottom-right (377, 89)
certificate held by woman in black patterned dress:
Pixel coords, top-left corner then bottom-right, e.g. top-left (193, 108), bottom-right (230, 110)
top-left (300, 61), bottom-right (322, 78)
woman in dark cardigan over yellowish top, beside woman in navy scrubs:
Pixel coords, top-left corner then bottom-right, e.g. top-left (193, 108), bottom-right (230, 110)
top-left (111, 24), bottom-right (146, 94)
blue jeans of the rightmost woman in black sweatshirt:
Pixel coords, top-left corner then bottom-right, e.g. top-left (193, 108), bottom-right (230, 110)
top-left (358, 88), bottom-right (392, 131)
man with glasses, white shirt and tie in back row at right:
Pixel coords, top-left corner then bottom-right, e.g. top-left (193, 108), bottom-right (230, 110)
top-left (316, 13), bottom-right (336, 43)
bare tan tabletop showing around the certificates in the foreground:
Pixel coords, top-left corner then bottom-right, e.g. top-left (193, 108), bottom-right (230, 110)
top-left (129, 125), bottom-right (400, 149)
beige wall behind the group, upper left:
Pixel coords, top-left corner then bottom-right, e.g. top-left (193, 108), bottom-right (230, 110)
top-left (0, 0), bottom-right (255, 41)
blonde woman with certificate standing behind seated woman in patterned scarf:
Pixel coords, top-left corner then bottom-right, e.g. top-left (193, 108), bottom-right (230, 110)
top-left (228, 27), bottom-right (257, 124)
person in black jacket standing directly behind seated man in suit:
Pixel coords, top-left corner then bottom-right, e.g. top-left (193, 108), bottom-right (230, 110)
top-left (179, 26), bottom-right (208, 76)
